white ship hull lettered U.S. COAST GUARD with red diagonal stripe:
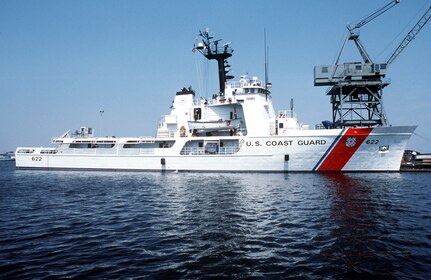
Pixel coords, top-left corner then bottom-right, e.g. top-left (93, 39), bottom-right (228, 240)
top-left (16, 126), bottom-right (416, 172)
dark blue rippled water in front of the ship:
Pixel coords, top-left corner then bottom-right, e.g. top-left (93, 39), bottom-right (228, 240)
top-left (0, 162), bottom-right (431, 279)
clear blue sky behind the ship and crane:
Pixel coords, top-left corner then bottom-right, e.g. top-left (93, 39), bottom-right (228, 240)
top-left (0, 0), bottom-right (431, 152)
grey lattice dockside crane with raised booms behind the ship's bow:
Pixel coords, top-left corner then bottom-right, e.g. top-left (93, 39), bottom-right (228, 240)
top-left (314, 0), bottom-right (431, 127)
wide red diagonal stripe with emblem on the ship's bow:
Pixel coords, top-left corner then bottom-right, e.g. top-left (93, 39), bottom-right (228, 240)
top-left (317, 128), bottom-right (373, 171)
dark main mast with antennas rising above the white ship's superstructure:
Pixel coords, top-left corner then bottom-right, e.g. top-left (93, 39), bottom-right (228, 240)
top-left (195, 30), bottom-right (234, 95)
